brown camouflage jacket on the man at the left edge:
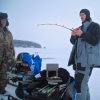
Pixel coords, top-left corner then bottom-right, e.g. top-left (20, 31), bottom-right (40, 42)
top-left (0, 28), bottom-right (15, 61)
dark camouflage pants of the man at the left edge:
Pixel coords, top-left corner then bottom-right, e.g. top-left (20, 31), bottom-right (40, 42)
top-left (0, 63), bottom-right (7, 90)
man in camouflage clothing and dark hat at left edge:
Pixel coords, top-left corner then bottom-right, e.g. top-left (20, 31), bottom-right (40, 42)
top-left (0, 12), bottom-right (15, 94)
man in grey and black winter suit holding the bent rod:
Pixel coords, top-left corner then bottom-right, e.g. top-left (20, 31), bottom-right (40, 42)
top-left (68, 9), bottom-right (100, 100)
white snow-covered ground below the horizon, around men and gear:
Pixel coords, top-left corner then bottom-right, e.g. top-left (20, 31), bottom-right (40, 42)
top-left (5, 47), bottom-right (100, 100)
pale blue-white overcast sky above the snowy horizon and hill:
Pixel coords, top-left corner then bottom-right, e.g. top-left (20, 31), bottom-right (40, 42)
top-left (0, 0), bottom-right (100, 48)
